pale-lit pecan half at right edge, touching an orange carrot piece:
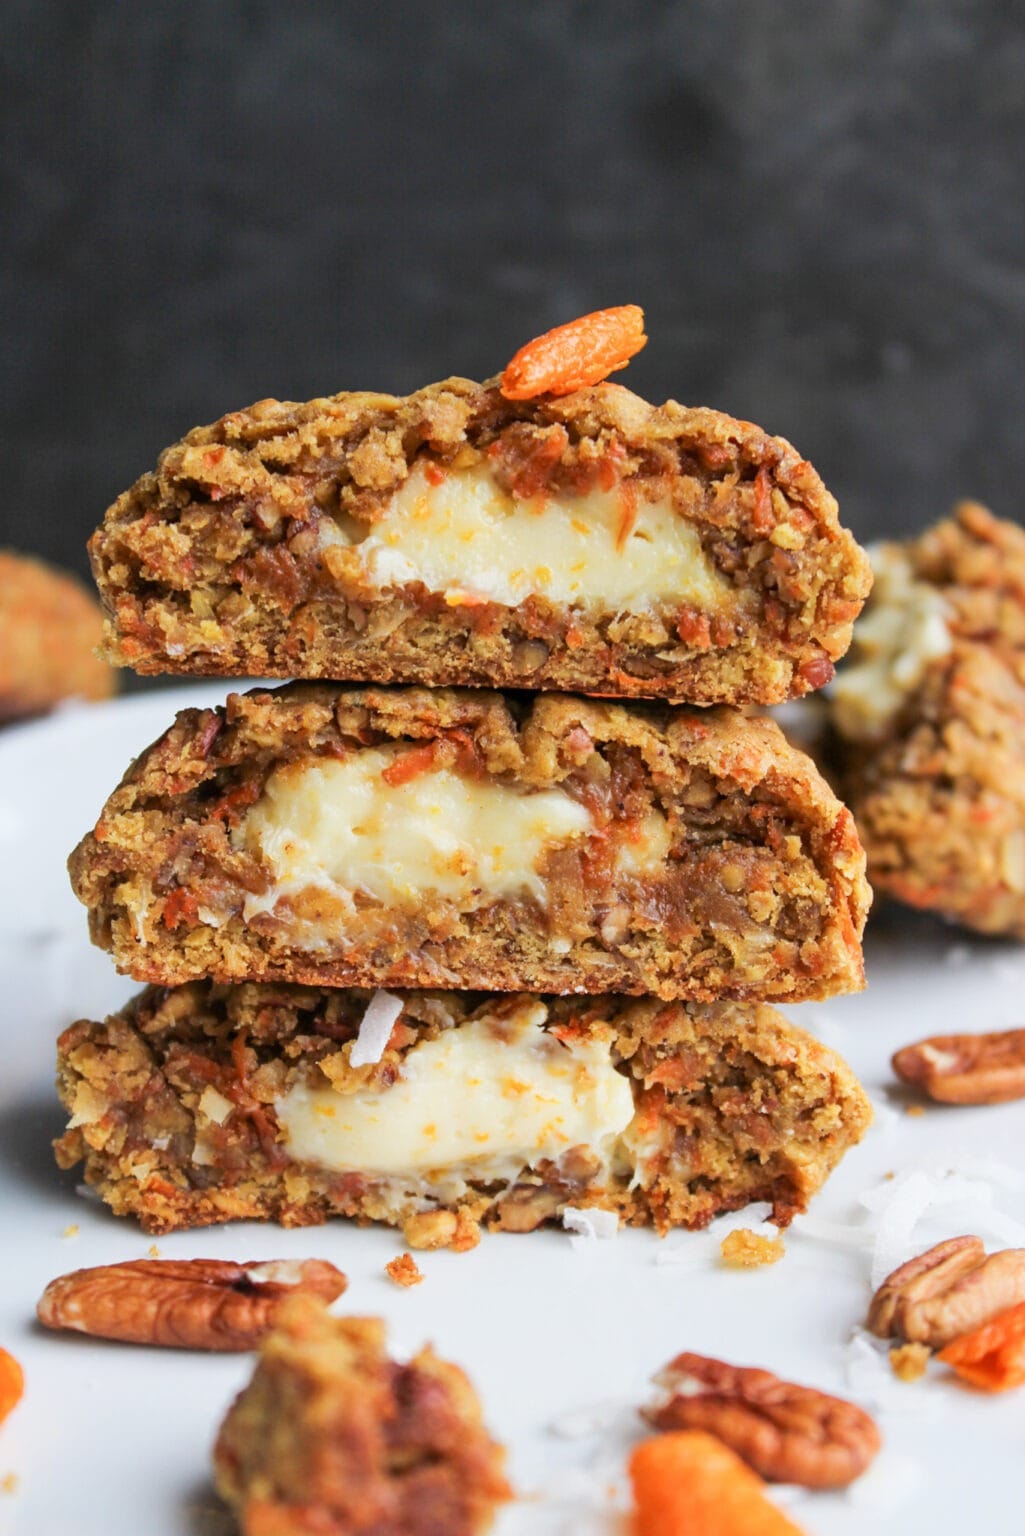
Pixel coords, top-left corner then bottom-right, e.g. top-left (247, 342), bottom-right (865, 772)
top-left (868, 1236), bottom-right (1025, 1349)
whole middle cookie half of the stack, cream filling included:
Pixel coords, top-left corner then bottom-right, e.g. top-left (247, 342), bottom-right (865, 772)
top-left (71, 684), bottom-right (868, 1001)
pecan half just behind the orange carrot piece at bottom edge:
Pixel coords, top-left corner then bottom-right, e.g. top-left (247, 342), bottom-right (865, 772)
top-left (641, 1353), bottom-right (881, 1488)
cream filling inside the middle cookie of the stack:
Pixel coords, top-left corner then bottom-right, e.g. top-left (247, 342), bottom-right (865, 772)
top-left (237, 746), bottom-right (592, 908)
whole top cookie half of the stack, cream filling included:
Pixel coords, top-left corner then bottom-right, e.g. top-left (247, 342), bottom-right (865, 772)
top-left (91, 378), bottom-right (870, 703)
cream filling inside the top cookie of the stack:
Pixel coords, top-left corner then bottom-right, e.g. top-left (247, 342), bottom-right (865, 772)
top-left (321, 465), bottom-right (733, 613)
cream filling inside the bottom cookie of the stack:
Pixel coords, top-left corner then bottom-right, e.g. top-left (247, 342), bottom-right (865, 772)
top-left (277, 1001), bottom-right (633, 1180)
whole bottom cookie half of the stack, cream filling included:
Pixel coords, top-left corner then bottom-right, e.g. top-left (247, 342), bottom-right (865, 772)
top-left (57, 982), bottom-right (871, 1247)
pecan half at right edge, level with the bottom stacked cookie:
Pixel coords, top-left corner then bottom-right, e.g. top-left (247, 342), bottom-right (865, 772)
top-left (891, 1029), bottom-right (1025, 1104)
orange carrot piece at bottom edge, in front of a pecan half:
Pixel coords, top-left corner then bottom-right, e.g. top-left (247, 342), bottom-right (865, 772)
top-left (630, 1430), bottom-right (802, 1536)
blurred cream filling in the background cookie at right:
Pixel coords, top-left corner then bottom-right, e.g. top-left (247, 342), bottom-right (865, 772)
top-left (830, 544), bottom-right (951, 740)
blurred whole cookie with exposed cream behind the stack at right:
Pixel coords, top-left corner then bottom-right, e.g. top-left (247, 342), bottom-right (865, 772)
top-left (830, 502), bottom-right (1025, 937)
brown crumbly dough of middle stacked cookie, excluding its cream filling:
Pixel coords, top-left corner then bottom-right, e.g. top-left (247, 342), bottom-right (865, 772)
top-left (71, 685), bottom-right (868, 1001)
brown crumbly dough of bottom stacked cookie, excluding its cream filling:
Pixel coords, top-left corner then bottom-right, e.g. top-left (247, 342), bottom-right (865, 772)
top-left (57, 982), bottom-right (870, 1249)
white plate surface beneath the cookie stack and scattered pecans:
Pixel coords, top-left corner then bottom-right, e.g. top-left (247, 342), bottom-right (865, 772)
top-left (0, 684), bottom-right (1025, 1536)
